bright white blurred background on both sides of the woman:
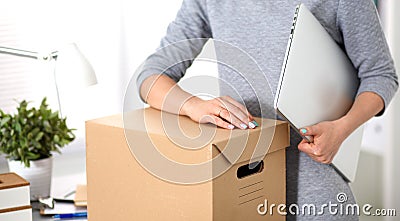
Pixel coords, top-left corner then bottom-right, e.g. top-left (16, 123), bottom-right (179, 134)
top-left (0, 0), bottom-right (400, 220)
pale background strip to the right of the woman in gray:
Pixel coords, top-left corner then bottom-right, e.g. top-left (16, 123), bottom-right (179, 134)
top-left (353, 0), bottom-right (400, 220)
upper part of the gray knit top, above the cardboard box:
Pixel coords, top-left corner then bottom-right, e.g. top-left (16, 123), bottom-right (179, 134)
top-left (138, 0), bottom-right (398, 117)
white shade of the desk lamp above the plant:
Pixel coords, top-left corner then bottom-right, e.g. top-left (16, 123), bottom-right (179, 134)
top-left (55, 43), bottom-right (97, 87)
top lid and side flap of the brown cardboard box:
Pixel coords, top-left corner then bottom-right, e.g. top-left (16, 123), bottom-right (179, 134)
top-left (90, 108), bottom-right (289, 164)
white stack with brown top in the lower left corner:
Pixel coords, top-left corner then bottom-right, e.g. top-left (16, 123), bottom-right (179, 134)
top-left (0, 173), bottom-right (32, 221)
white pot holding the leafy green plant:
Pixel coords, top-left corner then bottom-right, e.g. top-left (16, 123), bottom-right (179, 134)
top-left (8, 157), bottom-right (53, 200)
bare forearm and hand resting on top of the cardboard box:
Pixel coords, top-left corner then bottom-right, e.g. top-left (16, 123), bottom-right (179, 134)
top-left (140, 74), bottom-right (258, 129)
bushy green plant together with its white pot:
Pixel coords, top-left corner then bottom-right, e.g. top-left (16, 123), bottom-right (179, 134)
top-left (0, 98), bottom-right (75, 200)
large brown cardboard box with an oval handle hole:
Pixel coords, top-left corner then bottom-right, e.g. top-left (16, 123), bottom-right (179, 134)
top-left (86, 108), bottom-right (289, 221)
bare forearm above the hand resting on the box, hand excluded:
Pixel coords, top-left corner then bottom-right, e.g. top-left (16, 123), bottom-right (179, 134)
top-left (140, 74), bottom-right (199, 115)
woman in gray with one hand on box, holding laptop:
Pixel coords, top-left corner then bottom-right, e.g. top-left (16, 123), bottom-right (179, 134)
top-left (137, 0), bottom-right (398, 220)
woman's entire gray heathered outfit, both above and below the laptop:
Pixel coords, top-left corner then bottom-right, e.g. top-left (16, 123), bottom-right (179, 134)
top-left (137, 0), bottom-right (398, 220)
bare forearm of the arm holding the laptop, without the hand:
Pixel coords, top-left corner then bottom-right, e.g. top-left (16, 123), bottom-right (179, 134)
top-left (339, 92), bottom-right (384, 136)
